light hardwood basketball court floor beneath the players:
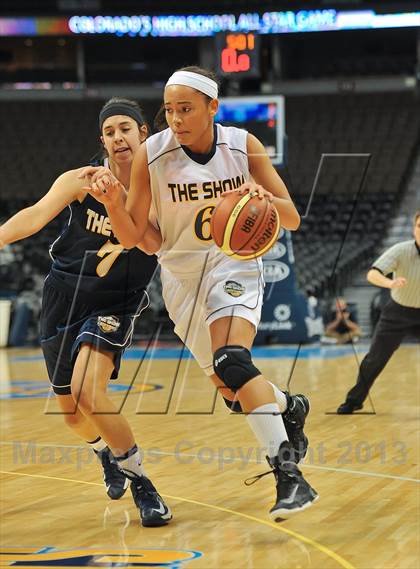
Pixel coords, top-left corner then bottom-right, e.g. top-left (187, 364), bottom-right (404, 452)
top-left (0, 345), bottom-right (420, 569)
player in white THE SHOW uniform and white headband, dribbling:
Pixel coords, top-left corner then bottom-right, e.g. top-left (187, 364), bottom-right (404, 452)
top-left (82, 67), bottom-right (318, 521)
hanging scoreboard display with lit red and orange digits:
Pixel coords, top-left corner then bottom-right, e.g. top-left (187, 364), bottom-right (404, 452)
top-left (216, 32), bottom-right (260, 77)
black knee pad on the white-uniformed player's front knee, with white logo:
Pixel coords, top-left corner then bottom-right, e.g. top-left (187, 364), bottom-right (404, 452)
top-left (213, 346), bottom-right (261, 392)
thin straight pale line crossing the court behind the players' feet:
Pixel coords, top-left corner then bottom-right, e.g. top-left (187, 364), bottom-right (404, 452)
top-left (0, 441), bottom-right (420, 484)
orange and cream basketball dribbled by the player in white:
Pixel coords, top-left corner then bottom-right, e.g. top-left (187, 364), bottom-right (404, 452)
top-left (210, 192), bottom-right (280, 260)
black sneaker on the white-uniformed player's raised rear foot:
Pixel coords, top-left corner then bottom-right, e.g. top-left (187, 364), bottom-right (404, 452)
top-left (282, 391), bottom-right (310, 463)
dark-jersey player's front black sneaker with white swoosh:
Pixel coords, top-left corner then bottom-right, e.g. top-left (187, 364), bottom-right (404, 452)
top-left (131, 476), bottom-right (172, 527)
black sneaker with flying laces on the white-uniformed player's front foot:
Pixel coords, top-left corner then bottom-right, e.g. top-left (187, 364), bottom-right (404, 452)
top-left (245, 441), bottom-right (319, 522)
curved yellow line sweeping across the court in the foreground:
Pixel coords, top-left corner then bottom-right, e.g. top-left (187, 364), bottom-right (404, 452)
top-left (0, 470), bottom-right (356, 569)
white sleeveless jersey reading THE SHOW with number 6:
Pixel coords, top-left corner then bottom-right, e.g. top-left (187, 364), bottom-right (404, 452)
top-left (146, 124), bottom-right (250, 276)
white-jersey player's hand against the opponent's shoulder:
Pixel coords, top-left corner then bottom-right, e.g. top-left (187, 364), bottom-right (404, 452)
top-left (78, 166), bottom-right (125, 207)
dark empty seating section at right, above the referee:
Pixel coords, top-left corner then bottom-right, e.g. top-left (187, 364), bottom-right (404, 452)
top-left (282, 92), bottom-right (420, 295)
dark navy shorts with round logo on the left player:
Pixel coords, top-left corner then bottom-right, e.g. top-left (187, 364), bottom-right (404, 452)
top-left (40, 277), bottom-right (149, 395)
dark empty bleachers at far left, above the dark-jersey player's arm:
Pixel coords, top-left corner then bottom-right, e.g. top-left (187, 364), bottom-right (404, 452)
top-left (0, 99), bottom-right (156, 200)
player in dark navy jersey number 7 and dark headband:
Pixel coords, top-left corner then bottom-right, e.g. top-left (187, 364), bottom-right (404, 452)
top-left (0, 98), bottom-right (172, 526)
